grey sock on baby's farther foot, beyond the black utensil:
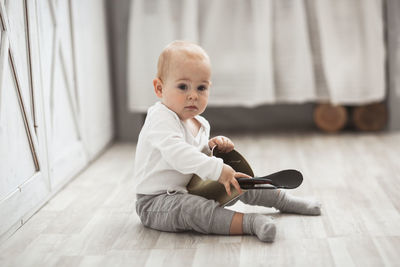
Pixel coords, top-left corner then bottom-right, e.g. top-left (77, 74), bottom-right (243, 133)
top-left (276, 191), bottom-right (321, 215)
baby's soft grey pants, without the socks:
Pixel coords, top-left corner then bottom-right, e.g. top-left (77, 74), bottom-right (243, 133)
top-left (136, 190), bottom-right (278, 235)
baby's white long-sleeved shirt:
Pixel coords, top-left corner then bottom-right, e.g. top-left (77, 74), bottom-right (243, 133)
top-left (134, 102), bottom-right (223, 195)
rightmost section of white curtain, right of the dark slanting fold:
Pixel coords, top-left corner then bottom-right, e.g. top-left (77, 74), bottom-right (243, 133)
top-left (314, 0), bottom-right (385, 104)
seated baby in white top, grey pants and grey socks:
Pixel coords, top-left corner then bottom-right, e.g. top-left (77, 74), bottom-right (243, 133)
top-left (134, 41), bottom-right (321, 242)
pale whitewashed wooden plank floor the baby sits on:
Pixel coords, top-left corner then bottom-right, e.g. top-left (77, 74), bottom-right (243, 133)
top-left (0, 133), bottom-right (400, 267)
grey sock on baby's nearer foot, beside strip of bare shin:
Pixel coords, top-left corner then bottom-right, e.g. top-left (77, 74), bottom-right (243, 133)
top-left (243, 213), bottom-right (276, 242)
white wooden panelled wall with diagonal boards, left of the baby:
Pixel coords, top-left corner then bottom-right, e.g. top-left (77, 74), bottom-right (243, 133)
top-left (0, 0), bottom-right (113, 241)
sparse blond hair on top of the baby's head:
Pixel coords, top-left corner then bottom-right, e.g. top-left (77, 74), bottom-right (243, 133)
top-left (157, 40), bottom-right (210, 81)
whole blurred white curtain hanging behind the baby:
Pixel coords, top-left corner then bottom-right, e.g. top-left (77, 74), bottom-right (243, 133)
top-left (128, 0), bottom-right (385, 111)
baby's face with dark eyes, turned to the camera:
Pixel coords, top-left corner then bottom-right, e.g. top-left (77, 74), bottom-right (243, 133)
top-left (159, 57), bottom-right (211, 120)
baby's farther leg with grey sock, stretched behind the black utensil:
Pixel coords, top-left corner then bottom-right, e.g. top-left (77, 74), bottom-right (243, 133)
top-left (240, 189), bottom-right (321, 215)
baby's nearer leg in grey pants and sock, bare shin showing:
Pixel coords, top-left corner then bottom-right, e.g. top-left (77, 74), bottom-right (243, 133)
top-left (136, 194), bottom-right (276, 242)
